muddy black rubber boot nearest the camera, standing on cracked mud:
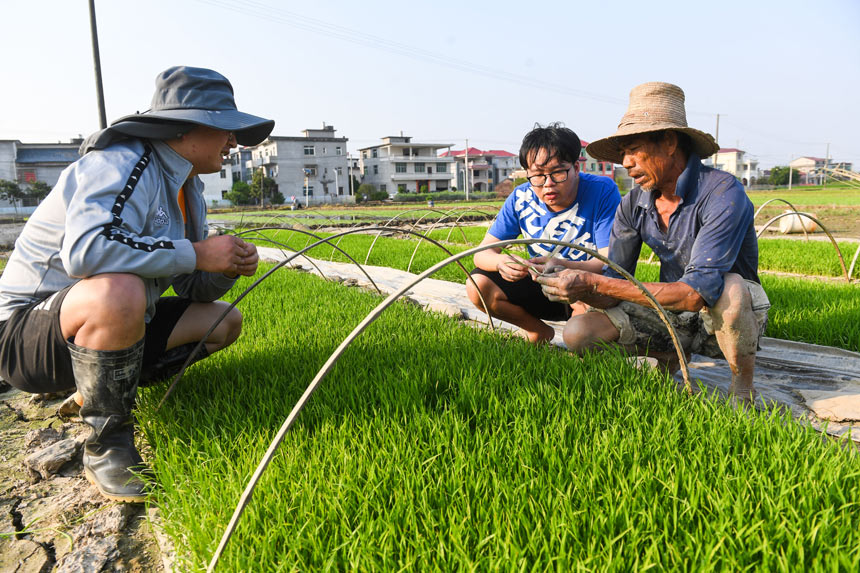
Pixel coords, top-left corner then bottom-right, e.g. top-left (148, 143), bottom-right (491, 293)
top-left (69, 339), bottom-right (146, 502)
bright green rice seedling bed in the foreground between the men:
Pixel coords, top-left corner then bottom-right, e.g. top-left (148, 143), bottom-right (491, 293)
top-left (138, 265), bottom-right (860, 571)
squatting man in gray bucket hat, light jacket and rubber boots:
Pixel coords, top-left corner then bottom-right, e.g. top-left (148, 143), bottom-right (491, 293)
top-left (0, 66), bottom-right (274, 502)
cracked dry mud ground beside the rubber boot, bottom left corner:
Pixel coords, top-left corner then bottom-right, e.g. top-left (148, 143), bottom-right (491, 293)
top-left (0, 382), bottom-right (172, 573)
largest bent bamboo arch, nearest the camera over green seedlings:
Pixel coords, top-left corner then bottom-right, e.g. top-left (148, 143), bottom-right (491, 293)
top-left (202, 239), bottom-right (692, 573)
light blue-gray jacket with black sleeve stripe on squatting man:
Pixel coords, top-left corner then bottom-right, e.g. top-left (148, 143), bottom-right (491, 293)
top-left (0, 139), bottom-right (235, 322)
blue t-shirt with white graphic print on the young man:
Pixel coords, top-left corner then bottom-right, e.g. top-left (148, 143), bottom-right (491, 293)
top-left (489, 173), bottom-right (621, 261)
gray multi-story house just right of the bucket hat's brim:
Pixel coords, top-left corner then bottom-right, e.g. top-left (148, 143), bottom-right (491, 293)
top-left (235, 124), bottom-right (353, 206)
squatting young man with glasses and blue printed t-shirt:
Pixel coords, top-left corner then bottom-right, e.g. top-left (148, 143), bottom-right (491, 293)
top-left (466, 123), bottom-right (621, 343)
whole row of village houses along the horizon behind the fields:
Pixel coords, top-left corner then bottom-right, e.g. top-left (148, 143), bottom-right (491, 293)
top-left (0, 124), bottom-right (850, 213)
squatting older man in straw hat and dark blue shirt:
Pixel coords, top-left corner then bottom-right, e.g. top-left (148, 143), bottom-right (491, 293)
top-left (537, 82), bottom-right (770, 403)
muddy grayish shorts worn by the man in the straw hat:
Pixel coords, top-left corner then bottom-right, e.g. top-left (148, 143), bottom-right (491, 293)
top-left (589, 280), bottom-right (770, 358)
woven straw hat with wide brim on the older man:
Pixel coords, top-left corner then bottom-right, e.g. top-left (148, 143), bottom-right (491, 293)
top-left (586, 82), bottom-right (720, 163)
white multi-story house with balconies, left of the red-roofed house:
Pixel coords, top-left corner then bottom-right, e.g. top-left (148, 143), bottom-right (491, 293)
top-left (358, 135), bottom-right (454, 196)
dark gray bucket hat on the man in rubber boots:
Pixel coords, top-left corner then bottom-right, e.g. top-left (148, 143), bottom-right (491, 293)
top-left (111, 66), bottom-right (275, 145)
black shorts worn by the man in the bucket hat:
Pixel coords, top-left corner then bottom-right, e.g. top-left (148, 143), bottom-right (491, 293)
top-left (0, 286), bottom-right (191, 393)
